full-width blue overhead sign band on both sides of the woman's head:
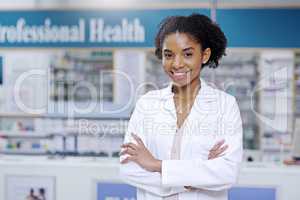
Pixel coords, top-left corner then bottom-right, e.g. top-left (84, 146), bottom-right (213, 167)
top-left (0, 8), bottom-right (300, 48)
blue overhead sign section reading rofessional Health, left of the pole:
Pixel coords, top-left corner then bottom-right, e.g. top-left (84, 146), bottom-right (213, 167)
top-left (0, 9), bottom-right (208, 47)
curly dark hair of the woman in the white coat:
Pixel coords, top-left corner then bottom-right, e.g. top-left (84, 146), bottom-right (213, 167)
top-left (155, 13), bottom-right (227, 68)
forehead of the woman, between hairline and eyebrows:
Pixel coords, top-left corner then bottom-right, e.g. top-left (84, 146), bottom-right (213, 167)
top-left (163, 32), bottom-right (200, 50)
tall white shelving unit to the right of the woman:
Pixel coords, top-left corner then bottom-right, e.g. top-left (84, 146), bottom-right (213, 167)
top-left (257, 50), bottom-right (295, 163)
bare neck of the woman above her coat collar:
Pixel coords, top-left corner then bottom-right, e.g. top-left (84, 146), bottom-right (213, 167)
top-left (172, 78), bottom-right (201, 99)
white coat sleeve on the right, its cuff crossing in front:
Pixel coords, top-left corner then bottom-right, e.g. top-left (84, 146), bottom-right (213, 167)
top-left (162, 97), bottom-right (243, 191)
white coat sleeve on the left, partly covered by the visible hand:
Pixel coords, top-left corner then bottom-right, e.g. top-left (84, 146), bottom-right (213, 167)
top-left (120, 97), bottom-right (186, 197)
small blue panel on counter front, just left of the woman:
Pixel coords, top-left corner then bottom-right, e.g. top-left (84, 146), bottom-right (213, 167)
top-left (97, 183), bottom-right (136, 200)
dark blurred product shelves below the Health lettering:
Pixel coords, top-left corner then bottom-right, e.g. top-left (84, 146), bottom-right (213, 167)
top-left (50, 51), bottom-right (114, 102)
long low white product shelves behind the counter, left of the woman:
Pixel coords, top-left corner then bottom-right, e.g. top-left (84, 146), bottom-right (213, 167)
top-left (0, 117), bottom-right (128, 157)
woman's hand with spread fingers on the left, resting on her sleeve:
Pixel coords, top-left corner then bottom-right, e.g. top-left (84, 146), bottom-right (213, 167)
top-left (120, 133), bottom-right (161, 172)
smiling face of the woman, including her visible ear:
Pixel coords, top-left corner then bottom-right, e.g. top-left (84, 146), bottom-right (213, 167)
top-left (162, 32), bottom-right (211, 87)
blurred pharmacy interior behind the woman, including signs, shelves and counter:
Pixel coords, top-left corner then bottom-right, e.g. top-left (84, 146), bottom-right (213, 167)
top-left (0, 0), bottom-right (300, 200)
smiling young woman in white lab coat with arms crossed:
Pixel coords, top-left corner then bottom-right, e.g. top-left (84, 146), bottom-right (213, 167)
top-left (120, 14), bottom-right (243, 200)
